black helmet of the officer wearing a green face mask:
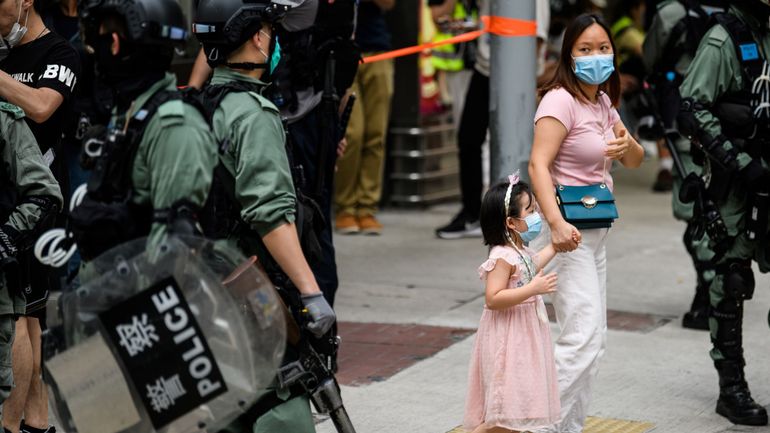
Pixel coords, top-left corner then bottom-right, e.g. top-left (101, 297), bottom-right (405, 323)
top-left (192, 0), bottom-right (288, 66)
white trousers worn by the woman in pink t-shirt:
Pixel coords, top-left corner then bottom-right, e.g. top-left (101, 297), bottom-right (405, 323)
top-left (537, 227), bottom-right (609, 433)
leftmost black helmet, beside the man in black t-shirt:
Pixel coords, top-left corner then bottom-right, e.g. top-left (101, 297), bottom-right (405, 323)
top-left (79, 0), bottom-right (188, 47)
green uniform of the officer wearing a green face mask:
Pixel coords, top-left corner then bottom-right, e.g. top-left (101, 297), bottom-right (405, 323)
top-left (204, 61), bottom-right (315, 433)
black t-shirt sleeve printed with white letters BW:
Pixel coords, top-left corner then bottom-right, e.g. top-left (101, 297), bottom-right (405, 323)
top-left (36, 39), bottom-right (80, 102)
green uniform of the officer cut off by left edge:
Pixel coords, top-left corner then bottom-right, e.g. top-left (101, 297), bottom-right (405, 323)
top-left (0, 102), bottom-right (62, 403)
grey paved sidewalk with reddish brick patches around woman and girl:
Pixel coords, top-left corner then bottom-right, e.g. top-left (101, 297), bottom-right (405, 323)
top-left (317, 163), bottom-right (770, 433)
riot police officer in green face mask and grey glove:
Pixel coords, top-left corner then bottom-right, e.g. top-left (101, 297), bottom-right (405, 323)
top-left (193, 0), bottom-right (335, 433)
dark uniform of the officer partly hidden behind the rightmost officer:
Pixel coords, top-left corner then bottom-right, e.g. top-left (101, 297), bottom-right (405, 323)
top-left (643, 0), bottom-right (714, 329)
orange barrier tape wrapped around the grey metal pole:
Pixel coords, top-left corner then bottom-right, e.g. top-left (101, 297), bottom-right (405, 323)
top-left (364, 16), bottom-right (537, 63)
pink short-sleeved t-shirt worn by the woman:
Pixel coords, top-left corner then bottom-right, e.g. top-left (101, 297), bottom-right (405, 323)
top-left (535, 88), bottom-right (620, 190)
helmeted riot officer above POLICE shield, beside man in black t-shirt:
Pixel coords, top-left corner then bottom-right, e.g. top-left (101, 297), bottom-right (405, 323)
top-left (70, 0), bottom-right (217, 255)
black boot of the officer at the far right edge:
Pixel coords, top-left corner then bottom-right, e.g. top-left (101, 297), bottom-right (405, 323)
top-left (714, 360), bottom-right (767, 425)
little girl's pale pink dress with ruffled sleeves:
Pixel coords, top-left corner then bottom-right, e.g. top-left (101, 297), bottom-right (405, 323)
top-left (464, 246), bottom-right (561, 431)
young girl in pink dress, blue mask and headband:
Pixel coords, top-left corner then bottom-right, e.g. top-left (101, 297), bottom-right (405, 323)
top-left (464, 175), bottom-right (560, 433)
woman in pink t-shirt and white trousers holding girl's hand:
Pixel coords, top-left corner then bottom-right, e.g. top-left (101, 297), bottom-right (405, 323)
top-left (529, 14), bottom-right (644, 433)
